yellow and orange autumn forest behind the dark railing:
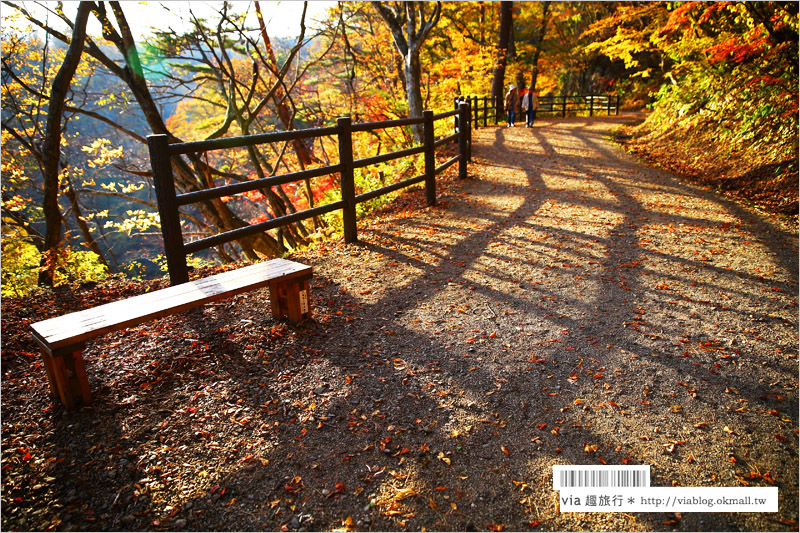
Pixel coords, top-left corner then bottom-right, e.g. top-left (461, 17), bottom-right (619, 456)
top-left (2, 1), bottom-right (798, 295)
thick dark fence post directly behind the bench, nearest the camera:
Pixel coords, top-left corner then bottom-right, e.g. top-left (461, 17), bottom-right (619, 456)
top-left (147, 134), bottom-right (189, 285)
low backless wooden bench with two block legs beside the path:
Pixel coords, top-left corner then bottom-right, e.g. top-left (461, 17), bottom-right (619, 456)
top-left (31, 259), bottom-right (312, 409)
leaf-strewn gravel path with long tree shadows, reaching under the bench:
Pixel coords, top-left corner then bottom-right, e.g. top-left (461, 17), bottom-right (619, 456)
top-left (3, 117), bottom-right (798, 531)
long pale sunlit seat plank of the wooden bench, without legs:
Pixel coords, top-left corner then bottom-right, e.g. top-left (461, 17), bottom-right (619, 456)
top-left (31, 259), bottom-right (312, 353)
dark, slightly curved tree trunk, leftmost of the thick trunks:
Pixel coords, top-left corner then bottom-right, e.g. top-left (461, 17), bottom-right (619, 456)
top-left (39, 2), bottom-right (93, 287)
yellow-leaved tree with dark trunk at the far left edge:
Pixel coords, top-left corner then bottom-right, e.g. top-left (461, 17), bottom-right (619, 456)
top-left (2, 3), bottom-right (115, 286)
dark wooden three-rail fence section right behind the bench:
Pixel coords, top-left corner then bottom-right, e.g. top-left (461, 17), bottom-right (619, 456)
top-left (147, 102), bottom-right (471, 285)
